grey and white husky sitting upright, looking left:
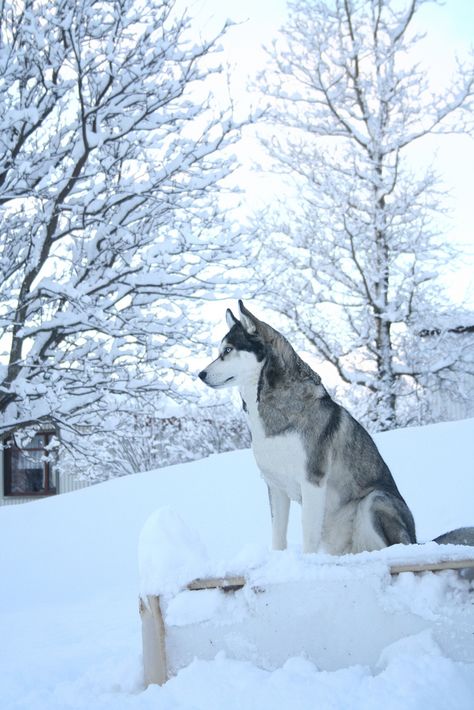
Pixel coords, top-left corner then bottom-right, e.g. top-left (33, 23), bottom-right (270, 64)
top-left (199, 301), bottom-right (416, 555)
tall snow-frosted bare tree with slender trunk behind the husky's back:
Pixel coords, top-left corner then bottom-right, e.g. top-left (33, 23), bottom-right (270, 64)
top-left (259, 0), bottom-right (474, 429)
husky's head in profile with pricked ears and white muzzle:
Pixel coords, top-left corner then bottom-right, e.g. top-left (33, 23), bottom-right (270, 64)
top-left (199, 301), bottom-right (276, 389)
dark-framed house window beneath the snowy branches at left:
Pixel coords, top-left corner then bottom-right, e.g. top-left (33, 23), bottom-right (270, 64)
top-left (3, 432), bottom-right (56, 496)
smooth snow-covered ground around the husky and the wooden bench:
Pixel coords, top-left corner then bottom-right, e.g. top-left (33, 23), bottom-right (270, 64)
top-left (0, 420), bottom-right (474, 710)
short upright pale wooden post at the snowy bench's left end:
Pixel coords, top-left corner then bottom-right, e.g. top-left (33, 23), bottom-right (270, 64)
top-left (140, 596), bottom-right (168, 687)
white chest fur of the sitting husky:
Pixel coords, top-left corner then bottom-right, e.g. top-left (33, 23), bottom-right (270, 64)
top-left (241, 387), bottom-right (307, 503)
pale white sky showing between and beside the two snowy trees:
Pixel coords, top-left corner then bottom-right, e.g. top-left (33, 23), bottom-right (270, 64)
top-left (187, 0), bottom-right (474, 308)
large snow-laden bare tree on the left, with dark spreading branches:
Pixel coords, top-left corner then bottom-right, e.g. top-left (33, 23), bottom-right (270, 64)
top-left (0, 0), bottom-right (243, 442)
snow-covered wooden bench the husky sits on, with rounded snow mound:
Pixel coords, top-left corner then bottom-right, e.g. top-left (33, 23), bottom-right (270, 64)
top-left (139, 509), bottom-right (474, 685)
